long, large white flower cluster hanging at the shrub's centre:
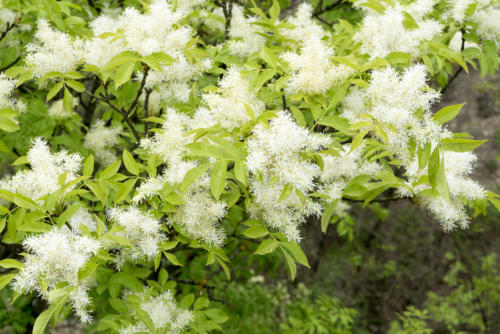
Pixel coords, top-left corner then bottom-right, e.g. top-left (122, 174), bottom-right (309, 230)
top-left (246, 111), bottom-right (330, 241)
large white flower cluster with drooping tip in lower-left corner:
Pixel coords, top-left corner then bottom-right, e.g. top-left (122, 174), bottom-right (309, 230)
top-left (13, 228), bottom-right (101, 323)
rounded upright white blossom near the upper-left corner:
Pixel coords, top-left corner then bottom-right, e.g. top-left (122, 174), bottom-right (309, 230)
top-left (25, 20), bottom-right (81, 78)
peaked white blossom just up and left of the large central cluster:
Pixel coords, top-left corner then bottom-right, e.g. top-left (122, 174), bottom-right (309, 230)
top-left (193, 67), bottom-right (264, 129)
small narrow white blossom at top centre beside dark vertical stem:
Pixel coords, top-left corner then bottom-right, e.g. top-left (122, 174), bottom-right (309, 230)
top-left (228, 6), bottom-right (266, 57)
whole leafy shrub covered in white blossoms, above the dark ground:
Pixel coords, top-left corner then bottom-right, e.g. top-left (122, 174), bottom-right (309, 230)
top-left (0, 0), bottom-right (500, 333)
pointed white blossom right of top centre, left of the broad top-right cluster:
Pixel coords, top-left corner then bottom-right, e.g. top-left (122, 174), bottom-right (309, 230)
top-left (282, 36), bottom-right (352, 94)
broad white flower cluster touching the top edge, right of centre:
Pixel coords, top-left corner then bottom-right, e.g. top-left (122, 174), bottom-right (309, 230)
top-left (354, 0), bottom-right (442, 58)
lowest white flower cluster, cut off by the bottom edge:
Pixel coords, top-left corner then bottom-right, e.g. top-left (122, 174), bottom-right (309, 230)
top-left (120, 291), bottom-right (193, 334)
